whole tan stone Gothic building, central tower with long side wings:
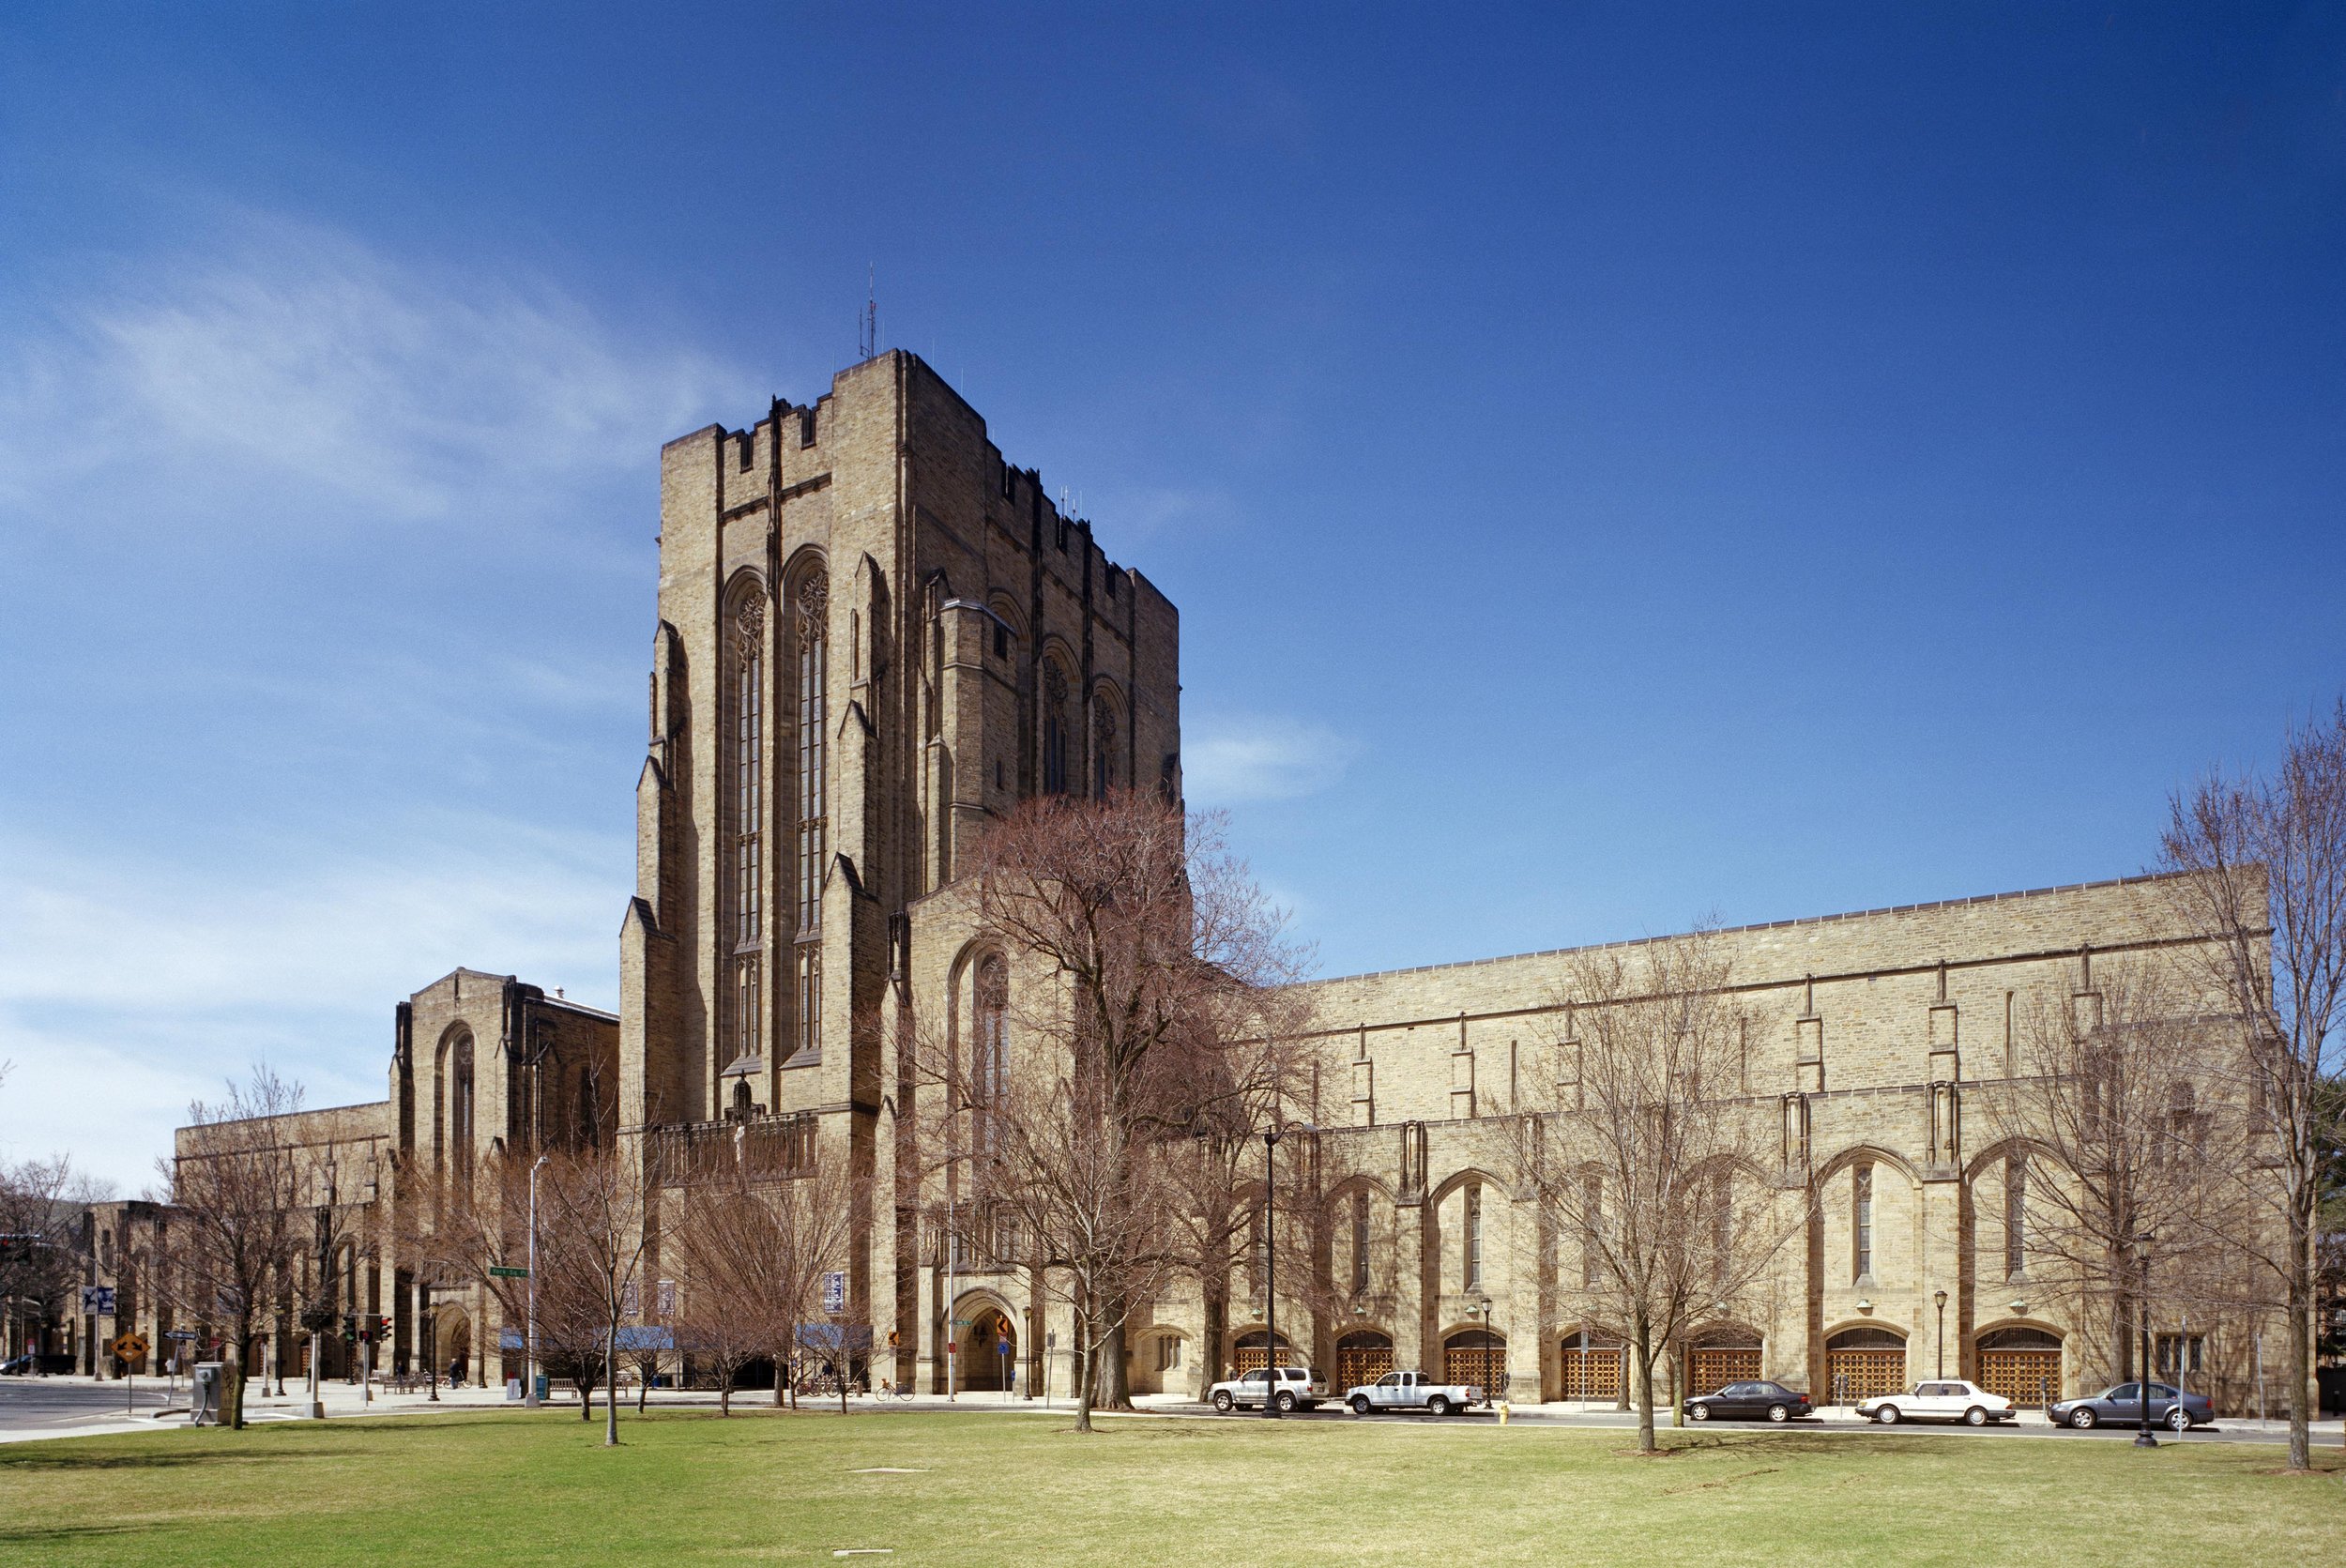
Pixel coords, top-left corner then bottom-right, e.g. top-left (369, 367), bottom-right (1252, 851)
top-left (87, 352), bottom-right (2278, 1406)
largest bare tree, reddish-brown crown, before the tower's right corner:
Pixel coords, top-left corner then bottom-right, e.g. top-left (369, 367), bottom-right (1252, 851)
top-left (924, 794), bottom-right (1300, 1432)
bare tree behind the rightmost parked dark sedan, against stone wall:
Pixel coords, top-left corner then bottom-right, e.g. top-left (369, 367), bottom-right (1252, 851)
top-left (1980, 958), bottom-right (2247, 1380)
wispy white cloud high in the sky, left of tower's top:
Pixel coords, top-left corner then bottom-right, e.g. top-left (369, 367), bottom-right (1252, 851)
top-left (0, 214), bottom-right (749, 528)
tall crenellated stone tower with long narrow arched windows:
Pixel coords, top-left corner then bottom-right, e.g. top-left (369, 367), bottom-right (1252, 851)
top-left (619, 352), bottom-right (1181, 1343)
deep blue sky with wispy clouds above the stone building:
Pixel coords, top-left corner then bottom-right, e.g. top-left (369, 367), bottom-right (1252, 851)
top-left (0, 5), bottom-right (2346, 1190)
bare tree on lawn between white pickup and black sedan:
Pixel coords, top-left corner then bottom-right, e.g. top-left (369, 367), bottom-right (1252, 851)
top-left (1497, 932), bottom-right (1809, 1453)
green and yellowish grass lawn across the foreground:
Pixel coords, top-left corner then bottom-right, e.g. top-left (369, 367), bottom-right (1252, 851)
top-left (0, 1410), bottom-right (2346, 1568)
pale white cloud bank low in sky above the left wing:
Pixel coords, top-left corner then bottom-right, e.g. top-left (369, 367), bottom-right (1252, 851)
top-left (0, 817), bottom-right (624, 1190)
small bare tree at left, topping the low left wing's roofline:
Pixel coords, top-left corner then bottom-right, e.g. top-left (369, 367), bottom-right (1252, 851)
top-left (158, 1063), bottom-right (305, 1427)
